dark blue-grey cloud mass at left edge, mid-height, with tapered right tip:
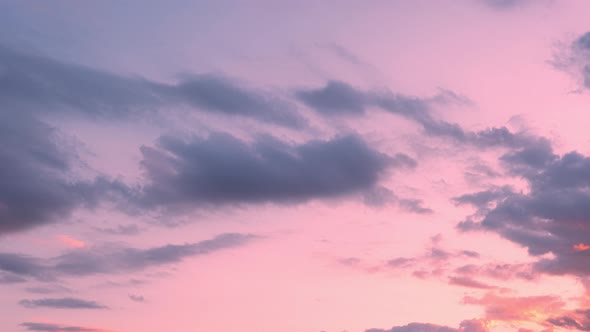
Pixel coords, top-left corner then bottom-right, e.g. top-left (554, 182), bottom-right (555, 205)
top-left (0, 111), bottom-right (133, 234)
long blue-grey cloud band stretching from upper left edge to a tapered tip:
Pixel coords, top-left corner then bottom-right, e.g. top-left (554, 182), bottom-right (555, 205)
top-left (0, 45), bottom-right (305, 127)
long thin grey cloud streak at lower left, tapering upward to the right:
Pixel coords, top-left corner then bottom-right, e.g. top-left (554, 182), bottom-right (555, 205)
top-left (0, 233), bottom-right (258, 281)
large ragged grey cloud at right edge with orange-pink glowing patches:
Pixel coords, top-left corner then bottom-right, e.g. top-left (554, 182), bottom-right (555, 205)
top-left (456, 149), bottom-right (590, 276)
